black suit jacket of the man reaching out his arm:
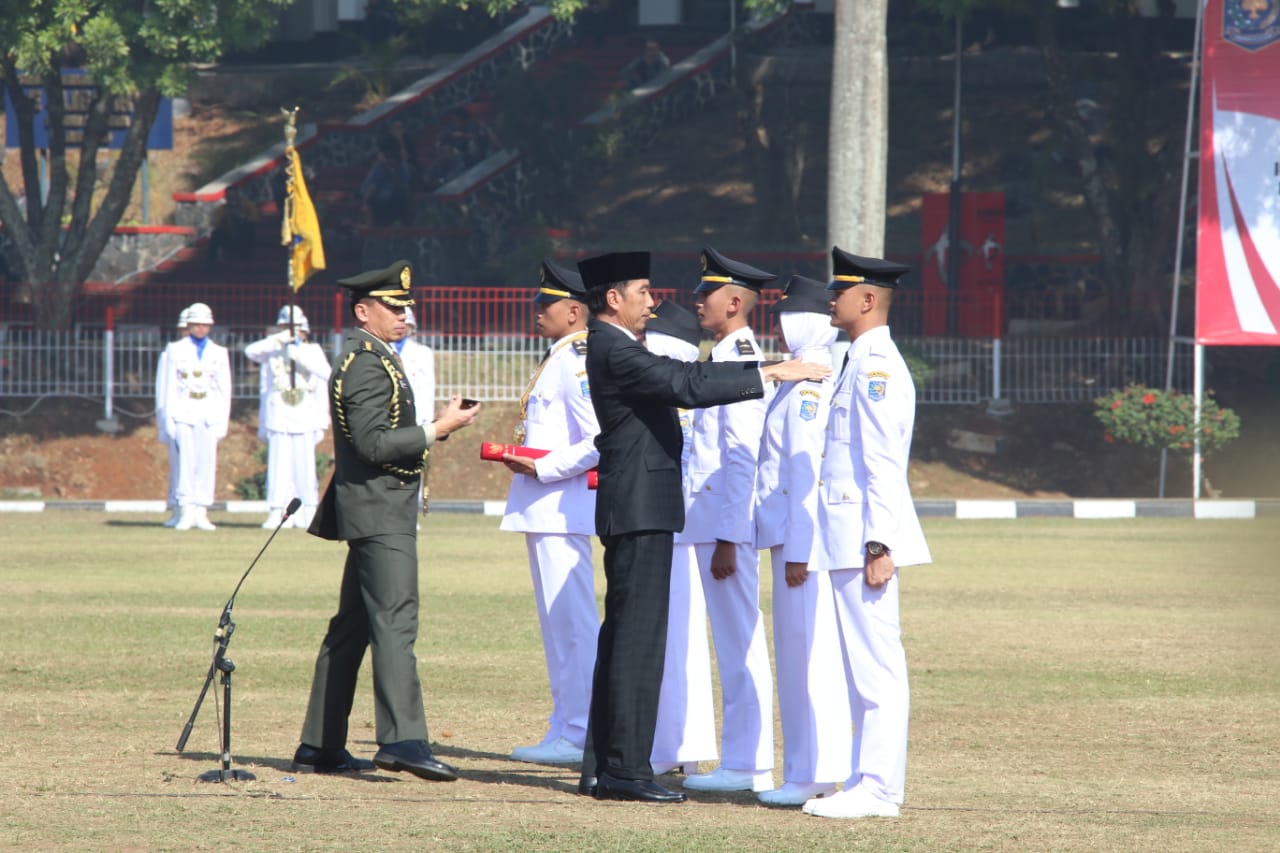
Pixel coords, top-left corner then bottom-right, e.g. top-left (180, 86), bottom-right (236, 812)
top-left (586, 319), bottom-right (764, 537)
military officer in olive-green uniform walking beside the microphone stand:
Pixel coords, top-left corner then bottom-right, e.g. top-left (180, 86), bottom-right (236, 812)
top-left (293, 261), bottom-right (479, 781)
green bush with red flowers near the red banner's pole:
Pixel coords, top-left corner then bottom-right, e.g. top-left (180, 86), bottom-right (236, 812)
top-left (1093, 384), bottom-right (1240, 455)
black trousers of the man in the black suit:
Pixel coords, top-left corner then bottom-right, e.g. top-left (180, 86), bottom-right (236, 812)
top-left (582, 530), bottom-right (673, 779)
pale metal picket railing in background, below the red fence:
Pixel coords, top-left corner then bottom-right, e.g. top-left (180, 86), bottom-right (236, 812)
top-left (0, 325), bottom-right (1192, 416)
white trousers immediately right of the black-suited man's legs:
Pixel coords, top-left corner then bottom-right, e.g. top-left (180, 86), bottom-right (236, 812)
top-left (650, 544), bottom-right (717, 765)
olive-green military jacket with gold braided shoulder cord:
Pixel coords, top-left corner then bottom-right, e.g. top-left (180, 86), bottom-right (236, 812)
top-left (310, 329), bottom-right (428, 539)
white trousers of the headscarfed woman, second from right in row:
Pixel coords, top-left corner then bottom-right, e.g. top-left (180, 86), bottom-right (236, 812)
top-left (769, 546), bottom-right (854, 784)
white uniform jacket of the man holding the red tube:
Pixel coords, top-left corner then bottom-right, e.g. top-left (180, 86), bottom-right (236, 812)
top-left (502, 336), bottom-right (600, 535)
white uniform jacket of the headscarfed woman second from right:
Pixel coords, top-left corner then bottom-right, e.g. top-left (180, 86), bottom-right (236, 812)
top-left (755, 371), bottom-right (833, 562)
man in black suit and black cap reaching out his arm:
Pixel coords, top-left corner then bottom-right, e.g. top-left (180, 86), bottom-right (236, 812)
top-left (577, 252), bottom-right (831, 803)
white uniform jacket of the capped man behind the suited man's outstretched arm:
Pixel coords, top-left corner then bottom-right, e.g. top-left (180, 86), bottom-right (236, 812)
top-left (676, 328), bottom-right (768, 546)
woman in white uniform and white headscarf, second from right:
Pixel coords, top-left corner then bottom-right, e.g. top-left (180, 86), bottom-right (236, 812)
top-left (755, 275), bottom-right (852, 806)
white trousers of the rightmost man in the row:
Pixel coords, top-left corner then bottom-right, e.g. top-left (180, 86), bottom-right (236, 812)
top-left (829, 569), bottom-right (911, 803)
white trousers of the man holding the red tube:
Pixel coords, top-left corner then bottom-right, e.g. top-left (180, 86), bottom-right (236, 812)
top-left (525, 533), bottom-right (600, 747)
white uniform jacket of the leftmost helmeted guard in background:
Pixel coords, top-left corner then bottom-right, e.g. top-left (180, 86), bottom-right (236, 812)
top-left (157, 336), bottom-right (232, 438)
